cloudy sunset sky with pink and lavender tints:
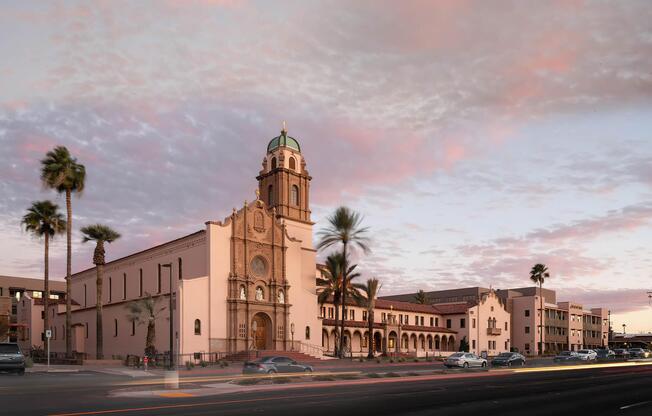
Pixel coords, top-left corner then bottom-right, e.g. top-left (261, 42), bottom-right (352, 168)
top-left (0, 0), bottom-right (652, 332)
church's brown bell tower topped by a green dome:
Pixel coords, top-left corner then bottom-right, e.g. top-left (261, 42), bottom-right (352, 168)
top-left (256, 122), bottom-right (312, 225)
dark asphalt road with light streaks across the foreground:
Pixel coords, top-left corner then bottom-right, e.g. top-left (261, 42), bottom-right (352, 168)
top-left (0, 365), bottom-right (652, 416)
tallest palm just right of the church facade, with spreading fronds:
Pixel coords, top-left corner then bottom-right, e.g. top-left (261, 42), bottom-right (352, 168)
top-left (317, 207), bottom-right (370, 358)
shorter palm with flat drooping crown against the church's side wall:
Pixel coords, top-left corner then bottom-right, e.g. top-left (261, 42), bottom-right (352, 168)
top-left (81, 224), bottom-right (120, 360)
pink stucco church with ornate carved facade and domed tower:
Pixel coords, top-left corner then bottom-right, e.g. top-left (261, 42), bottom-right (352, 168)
top-left (35, 128), bottom-right (322, 358)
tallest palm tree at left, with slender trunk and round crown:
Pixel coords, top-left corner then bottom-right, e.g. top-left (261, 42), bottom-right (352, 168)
top-left (41, 146), bottom-right (86, 356)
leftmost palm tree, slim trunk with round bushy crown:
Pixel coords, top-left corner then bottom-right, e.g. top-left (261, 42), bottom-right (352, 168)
top-left (21, 201), bottom-right (66, 342)
